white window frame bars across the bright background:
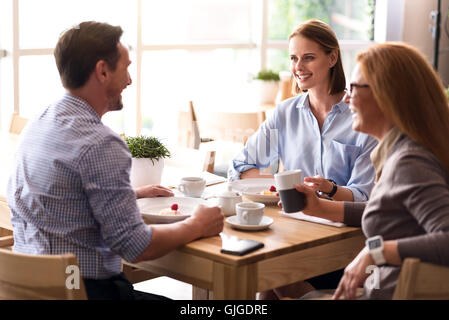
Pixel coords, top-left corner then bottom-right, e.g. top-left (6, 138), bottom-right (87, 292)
top-left (5, 0), bottom-right (388, 135)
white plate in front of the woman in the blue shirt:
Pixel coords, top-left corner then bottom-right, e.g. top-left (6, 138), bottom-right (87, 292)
top-left (231, 178), bottom-right (279, 204)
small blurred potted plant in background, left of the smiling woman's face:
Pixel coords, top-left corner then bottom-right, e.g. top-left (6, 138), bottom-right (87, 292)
top-left (253, 70), bottom-right (280, 104)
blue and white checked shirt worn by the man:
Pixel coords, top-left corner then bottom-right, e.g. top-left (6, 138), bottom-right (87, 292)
top-left (7, 94), bottom-right (152, 279)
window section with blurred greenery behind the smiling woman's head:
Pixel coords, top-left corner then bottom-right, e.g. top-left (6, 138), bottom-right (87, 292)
top-left (267, 0), bottom-right (375, 77)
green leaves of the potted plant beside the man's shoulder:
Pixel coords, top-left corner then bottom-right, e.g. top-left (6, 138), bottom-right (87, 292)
top-left (125, 135), bottom-right (170, 164)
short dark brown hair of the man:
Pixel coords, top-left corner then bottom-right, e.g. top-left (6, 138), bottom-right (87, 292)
top-left (54, 21), bottom-right (123, 89)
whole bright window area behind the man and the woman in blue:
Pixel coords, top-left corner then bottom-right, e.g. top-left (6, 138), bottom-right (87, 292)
top-left (0, 0), bottom-right (374, 144)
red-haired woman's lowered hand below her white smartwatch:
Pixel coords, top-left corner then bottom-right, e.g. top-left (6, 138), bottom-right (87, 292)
top-left (332, 247), bottom-right (374, 300)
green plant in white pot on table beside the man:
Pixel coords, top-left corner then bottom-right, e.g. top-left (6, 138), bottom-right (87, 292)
top-left (124, 136), bottom-right (170, 188)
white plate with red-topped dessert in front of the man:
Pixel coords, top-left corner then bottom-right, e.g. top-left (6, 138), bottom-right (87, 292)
top-left (137, 197), bottom-right (209, 223)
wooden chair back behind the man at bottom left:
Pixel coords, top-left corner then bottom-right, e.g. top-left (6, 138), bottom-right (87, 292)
top-left (0, 248), bottom-right (87, 300)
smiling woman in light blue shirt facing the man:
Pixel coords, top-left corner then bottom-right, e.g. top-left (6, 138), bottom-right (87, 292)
top-left (228, 19), bottom-right (377, 202)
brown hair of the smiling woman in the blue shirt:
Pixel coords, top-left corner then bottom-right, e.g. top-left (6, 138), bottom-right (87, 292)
top-left (288, 19), bottom-right (346, 95)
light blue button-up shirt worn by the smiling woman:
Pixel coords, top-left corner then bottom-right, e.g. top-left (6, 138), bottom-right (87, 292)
top-left (228, 94), bottom-right (377, 201)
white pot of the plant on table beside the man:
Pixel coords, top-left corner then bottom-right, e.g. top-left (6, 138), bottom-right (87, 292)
top-left (130, 158), bottom-right (164, 188)
